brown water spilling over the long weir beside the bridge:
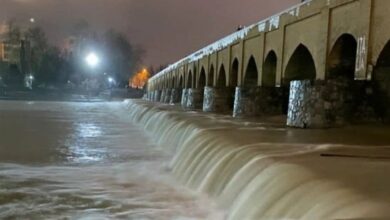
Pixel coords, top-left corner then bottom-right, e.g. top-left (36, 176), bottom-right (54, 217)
top-left (127, 101), bottom-right (390, 220)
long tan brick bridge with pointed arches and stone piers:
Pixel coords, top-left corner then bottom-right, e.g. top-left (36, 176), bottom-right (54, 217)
top-left (147, 0), bottom-right (390, 127)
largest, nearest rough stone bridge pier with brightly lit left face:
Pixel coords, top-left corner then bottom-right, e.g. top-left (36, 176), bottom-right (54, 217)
top-left (287, 80), bottom-right (357, 128)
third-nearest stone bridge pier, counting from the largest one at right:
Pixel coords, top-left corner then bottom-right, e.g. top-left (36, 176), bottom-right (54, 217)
top-left (203, 87), bottom-right (233, 113)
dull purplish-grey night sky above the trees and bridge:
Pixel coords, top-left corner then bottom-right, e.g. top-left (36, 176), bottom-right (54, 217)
top-left (0, 0), bottom-right (300, 66)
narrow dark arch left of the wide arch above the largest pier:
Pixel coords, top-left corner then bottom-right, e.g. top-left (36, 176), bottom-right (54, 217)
top-left (261, 50), bottom-right (278, 87)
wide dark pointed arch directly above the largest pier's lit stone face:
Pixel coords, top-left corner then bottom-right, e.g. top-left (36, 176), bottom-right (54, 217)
top-left (284, 44), bottom-right (316, 84)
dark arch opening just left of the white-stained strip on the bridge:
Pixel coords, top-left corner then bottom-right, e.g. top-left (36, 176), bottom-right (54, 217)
top-left (326, 34), bottom-right (357, 80)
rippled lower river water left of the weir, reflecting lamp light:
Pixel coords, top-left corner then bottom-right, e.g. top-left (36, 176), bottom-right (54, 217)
top-left (0, 101), bottom-right (223, 219)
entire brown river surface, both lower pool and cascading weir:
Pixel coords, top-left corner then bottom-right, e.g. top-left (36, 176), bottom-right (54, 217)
top-left (0, 100), bottom-right (390, 220)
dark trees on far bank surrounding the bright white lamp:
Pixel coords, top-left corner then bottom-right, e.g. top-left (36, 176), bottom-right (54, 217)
top-left (0, 22), bottom-right (144, 89)
